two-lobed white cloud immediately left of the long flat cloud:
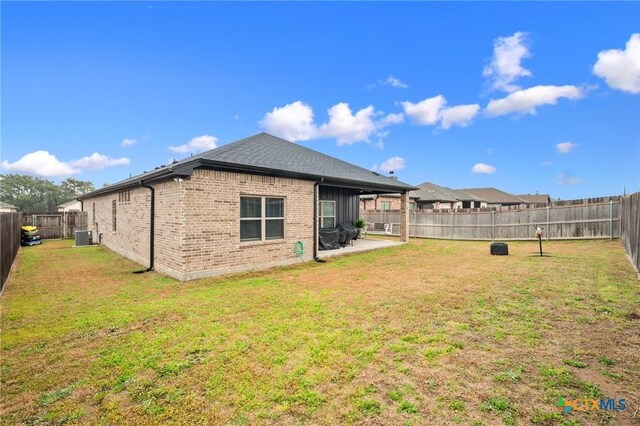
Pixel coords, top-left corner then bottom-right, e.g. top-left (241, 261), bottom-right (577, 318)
top-left (400, 95), bottom-right (480, 129)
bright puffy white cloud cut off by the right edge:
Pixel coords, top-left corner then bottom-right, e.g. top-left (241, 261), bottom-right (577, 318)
top-left (593, 33), bottom-right (640, 93)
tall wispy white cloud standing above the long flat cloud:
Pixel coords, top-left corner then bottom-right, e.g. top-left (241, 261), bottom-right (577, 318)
top-left (483, 31), bottom-right (531, 92)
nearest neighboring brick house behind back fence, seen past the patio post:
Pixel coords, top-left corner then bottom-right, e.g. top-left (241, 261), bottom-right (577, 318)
top-left (360, 182), bottom-right (487, 210)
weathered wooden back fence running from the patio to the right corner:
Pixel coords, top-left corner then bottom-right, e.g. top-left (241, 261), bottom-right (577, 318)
top-left (360, 197), bottom-right (620, 240)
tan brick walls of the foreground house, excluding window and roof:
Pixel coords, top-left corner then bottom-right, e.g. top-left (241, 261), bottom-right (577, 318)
top-left (84, 169), bottom-right (314, 280)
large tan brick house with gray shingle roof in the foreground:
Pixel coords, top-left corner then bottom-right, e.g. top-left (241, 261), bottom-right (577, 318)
top-left (79, 133), bottom-right (415, 280)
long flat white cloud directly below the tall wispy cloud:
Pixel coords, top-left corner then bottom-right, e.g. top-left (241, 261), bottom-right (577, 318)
top-left (485, 86), bottom-right (584, 117)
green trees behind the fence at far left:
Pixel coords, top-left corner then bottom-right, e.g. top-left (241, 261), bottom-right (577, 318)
top-left (0, 174), bottom-right (95, 214)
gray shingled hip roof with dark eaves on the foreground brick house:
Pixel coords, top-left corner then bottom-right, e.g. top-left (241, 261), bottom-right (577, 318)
top-left (78, 132), bottom-right (415, 199)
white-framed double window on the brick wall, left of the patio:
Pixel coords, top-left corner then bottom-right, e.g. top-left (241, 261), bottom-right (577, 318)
top-left (240, 196), bottom-right (284, 241)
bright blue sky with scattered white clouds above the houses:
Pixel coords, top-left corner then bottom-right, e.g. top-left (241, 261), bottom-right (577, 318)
top-left (1, 2), bottom-right (640, 199)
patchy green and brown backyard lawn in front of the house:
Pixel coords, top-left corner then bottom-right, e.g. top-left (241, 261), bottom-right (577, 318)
top-left (0, 240), bottom-right (640, 425)
